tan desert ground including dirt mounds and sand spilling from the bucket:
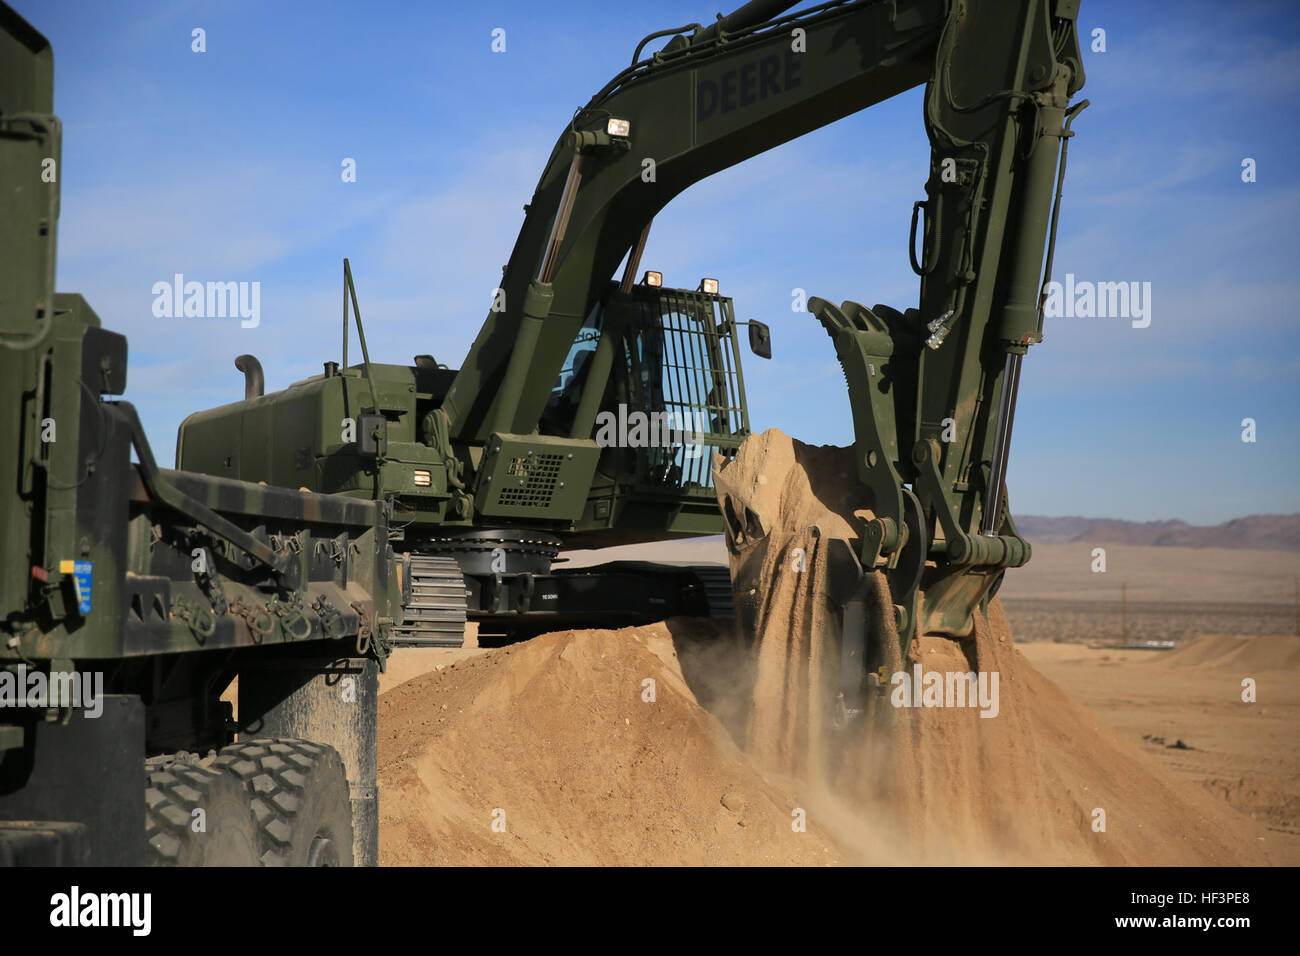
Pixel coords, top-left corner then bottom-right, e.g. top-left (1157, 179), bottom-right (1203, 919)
top-left (380, 433), bottom-right (1300, 865)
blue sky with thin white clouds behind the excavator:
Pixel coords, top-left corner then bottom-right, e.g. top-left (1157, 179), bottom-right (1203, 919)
top-left (10, 0), bottom-right (1300, 523)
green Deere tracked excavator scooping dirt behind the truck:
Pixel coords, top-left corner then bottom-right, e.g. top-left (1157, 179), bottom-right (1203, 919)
top-left (177, 1), bottom-right (1083, 655)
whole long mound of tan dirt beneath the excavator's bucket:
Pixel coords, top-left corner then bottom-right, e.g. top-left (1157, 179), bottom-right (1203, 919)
top-left (380, 613), bottom-right (1271, 865)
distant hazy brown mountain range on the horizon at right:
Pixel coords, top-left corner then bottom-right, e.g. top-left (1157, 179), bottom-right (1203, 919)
top-left (1015, 515), bottom-right (1300, 551)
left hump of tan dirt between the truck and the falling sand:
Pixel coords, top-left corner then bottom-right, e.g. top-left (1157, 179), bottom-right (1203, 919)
top-left (380, 620), bottom-right (844, 865)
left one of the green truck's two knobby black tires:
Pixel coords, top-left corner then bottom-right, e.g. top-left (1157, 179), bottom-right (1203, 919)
top-left (144, 754), bottom-right (261, 866)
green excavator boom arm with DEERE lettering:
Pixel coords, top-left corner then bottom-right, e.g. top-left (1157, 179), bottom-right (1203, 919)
top-left (443, 0), bottom-right (946, 442)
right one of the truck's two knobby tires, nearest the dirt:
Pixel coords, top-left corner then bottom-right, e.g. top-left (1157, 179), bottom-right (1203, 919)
top-left (212, 737), bottom-right (352, 866)
